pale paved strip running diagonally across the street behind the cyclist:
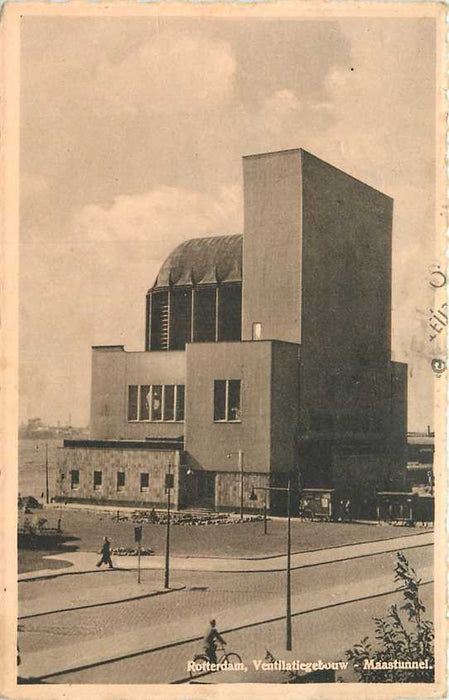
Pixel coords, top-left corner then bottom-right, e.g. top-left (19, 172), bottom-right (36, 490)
top-left (20, 567), bottom-right (432, 678)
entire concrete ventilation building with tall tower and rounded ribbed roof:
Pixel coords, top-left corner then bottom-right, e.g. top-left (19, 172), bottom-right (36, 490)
top-left (61, 149), bottom-right (407, 514)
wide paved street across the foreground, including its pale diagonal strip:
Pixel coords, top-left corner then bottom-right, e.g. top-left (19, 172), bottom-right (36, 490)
top-left (19, 537), bottom-right (433, 683)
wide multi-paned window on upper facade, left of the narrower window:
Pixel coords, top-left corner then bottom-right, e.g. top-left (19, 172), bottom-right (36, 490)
top-left (128, 384), bottom-right (185, 422)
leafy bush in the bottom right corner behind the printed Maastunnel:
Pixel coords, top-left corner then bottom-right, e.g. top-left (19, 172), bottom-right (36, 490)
top-left (346, 552), bottom-right (435, 683)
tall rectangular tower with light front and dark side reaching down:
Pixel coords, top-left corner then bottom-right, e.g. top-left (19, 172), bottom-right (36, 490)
top-left (242, 149), bottom-right (400, 504)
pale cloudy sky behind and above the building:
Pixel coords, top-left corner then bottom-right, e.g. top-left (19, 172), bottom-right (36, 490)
top-left (20, 15), bottom-right (435, 430)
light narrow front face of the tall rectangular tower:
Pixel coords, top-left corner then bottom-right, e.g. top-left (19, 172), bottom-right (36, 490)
top-left (242, 150), bottom-right (302, 343)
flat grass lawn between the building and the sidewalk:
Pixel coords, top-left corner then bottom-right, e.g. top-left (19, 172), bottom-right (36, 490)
top-left (15, 508), bottom-right (426, 571)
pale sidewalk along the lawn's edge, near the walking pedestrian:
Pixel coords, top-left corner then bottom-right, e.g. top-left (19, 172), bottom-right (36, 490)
top-left (19, 532), bottom-right (433, 582)
